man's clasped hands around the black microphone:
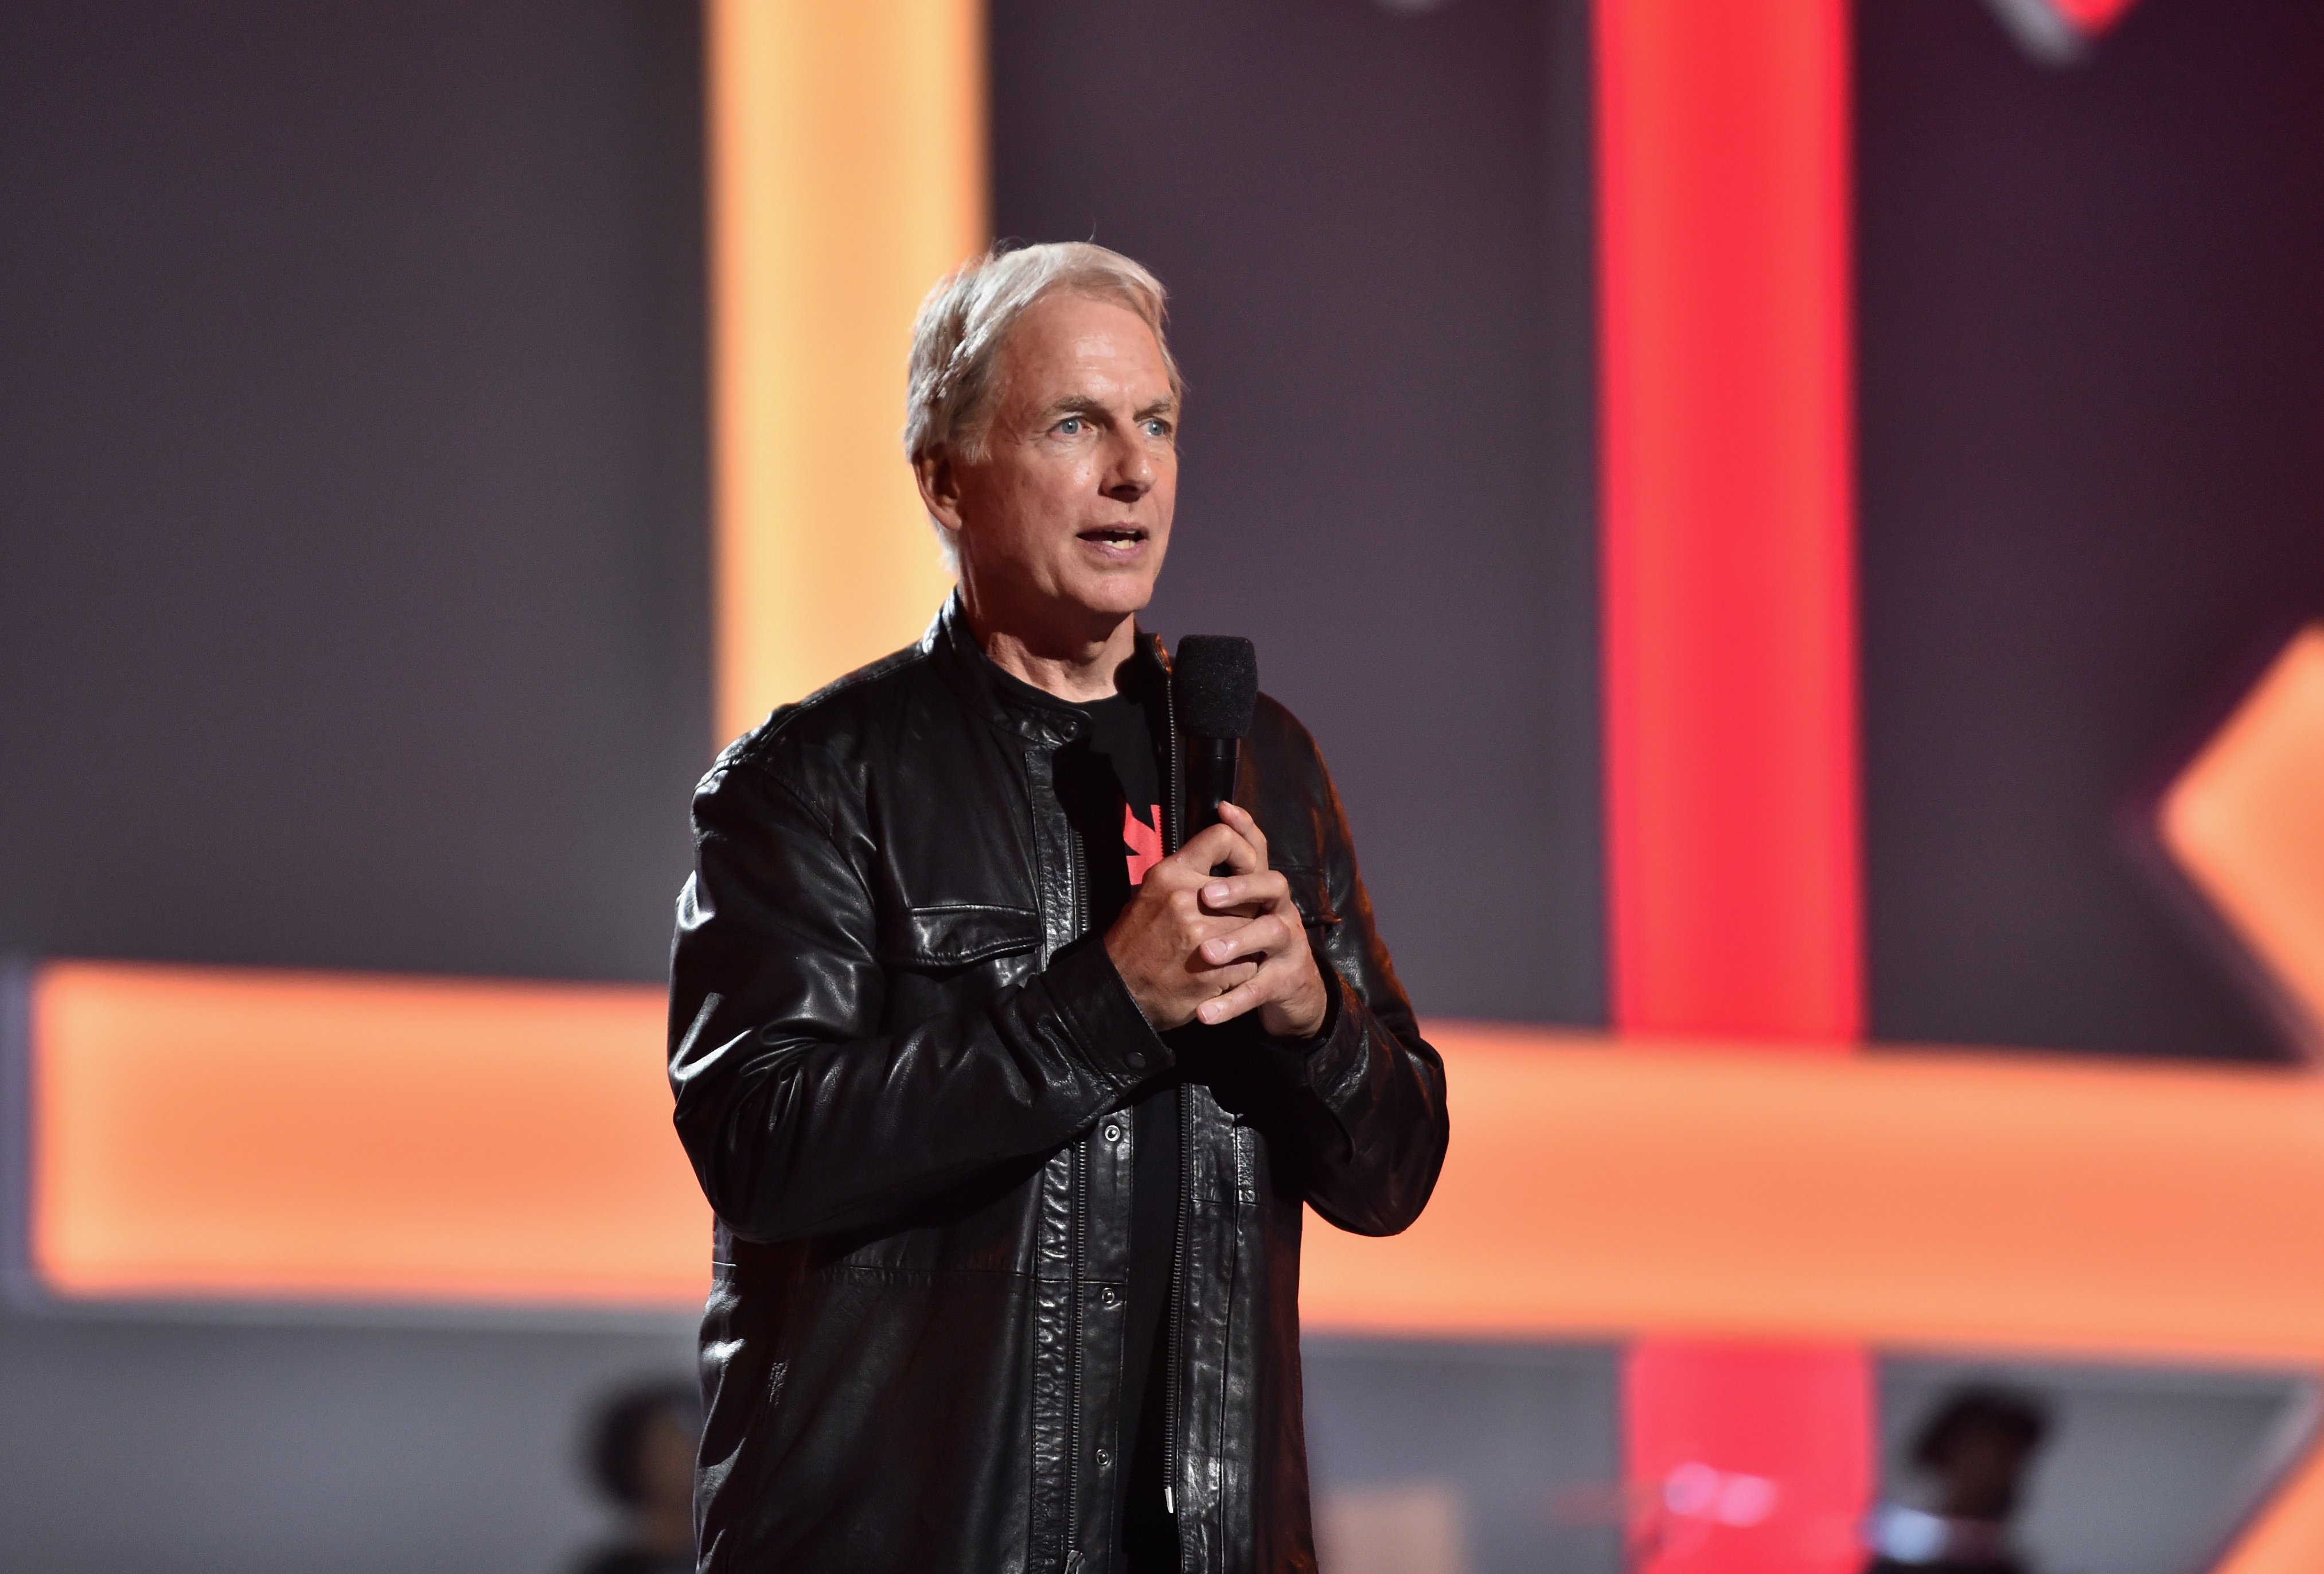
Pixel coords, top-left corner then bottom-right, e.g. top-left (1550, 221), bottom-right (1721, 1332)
top-left (1106, 804), bottom-right (1329, 1039)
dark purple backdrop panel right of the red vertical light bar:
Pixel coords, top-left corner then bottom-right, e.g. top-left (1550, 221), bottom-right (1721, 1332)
top-left (1857, 0), bottom-right (2324, 1058)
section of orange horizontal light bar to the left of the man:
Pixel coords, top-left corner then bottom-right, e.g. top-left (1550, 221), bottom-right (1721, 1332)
top-left (28, 963), bottom-right (709, 1307)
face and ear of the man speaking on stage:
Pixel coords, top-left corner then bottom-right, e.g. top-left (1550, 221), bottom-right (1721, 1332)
top-left (921, 291), bottom-right (1178, 642)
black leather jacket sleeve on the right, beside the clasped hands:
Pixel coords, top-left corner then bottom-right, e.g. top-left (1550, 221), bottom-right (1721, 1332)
top-left (1273, 744), bottom-right (1450, 1234)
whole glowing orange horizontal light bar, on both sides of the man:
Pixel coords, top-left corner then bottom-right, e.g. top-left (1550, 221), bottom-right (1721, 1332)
top-left (30, 963), bottom-right (2324, 1360)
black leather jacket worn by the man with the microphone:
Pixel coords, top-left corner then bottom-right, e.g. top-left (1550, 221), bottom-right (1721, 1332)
top-left (669, 600), bottom-right (1445, 1574)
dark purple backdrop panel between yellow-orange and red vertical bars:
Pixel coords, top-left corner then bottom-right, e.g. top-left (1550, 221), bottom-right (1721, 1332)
top-left (992, 0), bottom-right (1606, 1023)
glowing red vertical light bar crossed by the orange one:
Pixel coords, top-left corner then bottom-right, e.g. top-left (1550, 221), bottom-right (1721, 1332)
top-left (1597, 0), bottom-right (1871, 1574)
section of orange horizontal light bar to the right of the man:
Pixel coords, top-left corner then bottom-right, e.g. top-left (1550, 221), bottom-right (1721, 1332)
top-left (1301, 1023), bottom-right (2324, 1362)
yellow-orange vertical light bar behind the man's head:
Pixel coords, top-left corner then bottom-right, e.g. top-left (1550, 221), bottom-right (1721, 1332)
top-left (704, 0), bottom-right (988, 742)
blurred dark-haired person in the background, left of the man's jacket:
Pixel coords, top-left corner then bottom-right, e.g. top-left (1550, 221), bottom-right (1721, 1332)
top-left (574, 1381), bottom-right (702, 1574)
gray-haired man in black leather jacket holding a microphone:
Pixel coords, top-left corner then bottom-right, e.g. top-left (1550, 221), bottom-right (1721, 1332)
top-left (669, 244), bottom-right (1448, 1574)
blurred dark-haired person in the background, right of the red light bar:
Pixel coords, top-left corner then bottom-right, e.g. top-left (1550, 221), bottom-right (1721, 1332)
top-left (1866, 1388), bottom-right (2050, 1574)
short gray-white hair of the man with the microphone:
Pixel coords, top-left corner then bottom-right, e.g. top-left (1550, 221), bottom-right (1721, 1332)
top-left (904, 239), bottom-right (1186, 462)
